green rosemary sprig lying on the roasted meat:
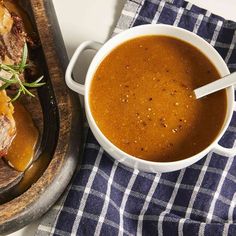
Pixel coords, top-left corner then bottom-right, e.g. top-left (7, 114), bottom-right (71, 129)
top-left (0, 43), bottom-right (45, 102)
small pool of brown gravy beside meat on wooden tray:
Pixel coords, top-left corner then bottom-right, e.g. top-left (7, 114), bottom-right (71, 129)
top-left (6, 102), bottom-right (39, 171)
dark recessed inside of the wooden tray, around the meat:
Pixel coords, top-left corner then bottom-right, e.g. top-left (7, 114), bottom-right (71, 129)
top-left (0, 1), bottom-right (59, 204)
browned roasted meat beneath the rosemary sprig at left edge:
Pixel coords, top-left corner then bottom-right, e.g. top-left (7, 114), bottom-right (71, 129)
top-left (0, 2), bottom-right (26, 157)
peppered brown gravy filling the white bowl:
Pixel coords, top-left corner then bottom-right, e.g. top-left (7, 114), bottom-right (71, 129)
top-left (89, 36), bottom-right (227, 162)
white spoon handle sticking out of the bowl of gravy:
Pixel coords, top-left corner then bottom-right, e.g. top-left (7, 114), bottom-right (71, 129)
top-left (194, 72), bottom-right (236, 99)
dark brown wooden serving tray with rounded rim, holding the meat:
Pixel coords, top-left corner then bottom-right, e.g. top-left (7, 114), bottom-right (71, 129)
top-left (0, 0), bottom-right (82, 234)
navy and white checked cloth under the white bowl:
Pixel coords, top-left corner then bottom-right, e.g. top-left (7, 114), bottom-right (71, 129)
top-left (36, 0), bottom-right (236, 236)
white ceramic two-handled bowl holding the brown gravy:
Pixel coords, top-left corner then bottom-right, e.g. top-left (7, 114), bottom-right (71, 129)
top-left (66, 25), bottom-right (236, 172)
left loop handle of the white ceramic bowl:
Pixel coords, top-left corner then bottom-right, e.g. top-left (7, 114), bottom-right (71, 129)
top-left (65, 41), bottom-right (102, 95)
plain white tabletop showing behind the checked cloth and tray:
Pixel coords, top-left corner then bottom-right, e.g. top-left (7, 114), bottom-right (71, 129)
top-left (7, 0), bottom-right (236, 236)
